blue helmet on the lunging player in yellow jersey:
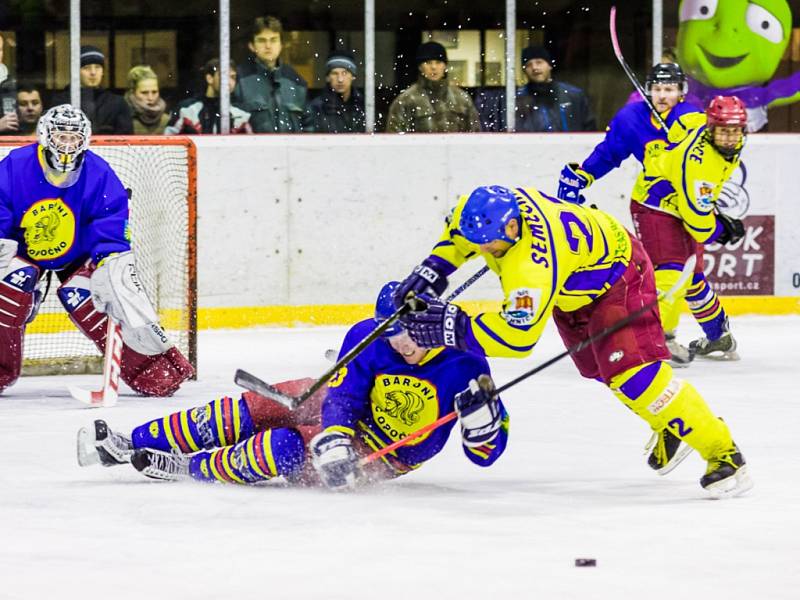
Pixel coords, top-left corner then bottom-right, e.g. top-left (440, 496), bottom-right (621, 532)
top-left (458, 185), bottom-right (519, 244)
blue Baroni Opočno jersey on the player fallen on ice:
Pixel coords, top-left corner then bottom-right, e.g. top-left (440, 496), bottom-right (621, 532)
top-left (322, 319), bottom-right (509, 474)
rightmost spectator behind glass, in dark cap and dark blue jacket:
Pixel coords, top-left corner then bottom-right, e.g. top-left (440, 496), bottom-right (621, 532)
top-left (515, 46), bottom-right (597, 132)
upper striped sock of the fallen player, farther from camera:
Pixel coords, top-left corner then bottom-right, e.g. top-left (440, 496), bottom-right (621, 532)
top-left (131, 396), bottom-right (255, 454)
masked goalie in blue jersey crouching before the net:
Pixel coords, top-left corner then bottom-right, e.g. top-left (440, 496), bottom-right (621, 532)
top-left (0, 104), bottom-right (194, 396)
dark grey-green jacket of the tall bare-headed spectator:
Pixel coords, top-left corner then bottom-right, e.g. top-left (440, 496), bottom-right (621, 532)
top-left (232, 55), bottom-right (309, 133)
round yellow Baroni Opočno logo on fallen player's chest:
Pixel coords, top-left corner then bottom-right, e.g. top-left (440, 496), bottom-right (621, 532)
top-left (370, 375), bottom-right (439, 445)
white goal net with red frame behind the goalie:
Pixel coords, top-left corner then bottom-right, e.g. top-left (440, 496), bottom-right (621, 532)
top-left (0, 136), bottom-right (197, 375)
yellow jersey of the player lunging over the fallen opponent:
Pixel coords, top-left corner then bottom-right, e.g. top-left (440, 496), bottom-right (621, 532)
top-left (432, 188), bottom-right (631, 358)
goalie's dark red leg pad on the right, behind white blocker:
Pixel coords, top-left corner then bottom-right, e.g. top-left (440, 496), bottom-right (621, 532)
top-left (58, 263), bottom-right (194, 396)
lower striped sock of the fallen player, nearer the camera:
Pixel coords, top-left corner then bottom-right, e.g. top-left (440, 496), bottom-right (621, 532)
top-left (189, 428), bottom-right (306, 483)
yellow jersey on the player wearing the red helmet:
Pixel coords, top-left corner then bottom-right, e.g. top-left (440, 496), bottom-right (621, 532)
top-left (633, 113), bottom-right (739, 243)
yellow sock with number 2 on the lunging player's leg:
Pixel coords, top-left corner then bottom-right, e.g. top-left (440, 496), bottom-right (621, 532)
top-left (610, 361), bottom-right (733, 460)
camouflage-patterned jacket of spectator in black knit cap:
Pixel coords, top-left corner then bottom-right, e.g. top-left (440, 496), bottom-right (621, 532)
top-left (386, 76), bottom-right (481, 133)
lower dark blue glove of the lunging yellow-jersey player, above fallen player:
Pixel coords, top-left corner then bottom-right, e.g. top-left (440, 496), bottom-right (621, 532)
top-left (401, 294), bottom-right (469, 351)
